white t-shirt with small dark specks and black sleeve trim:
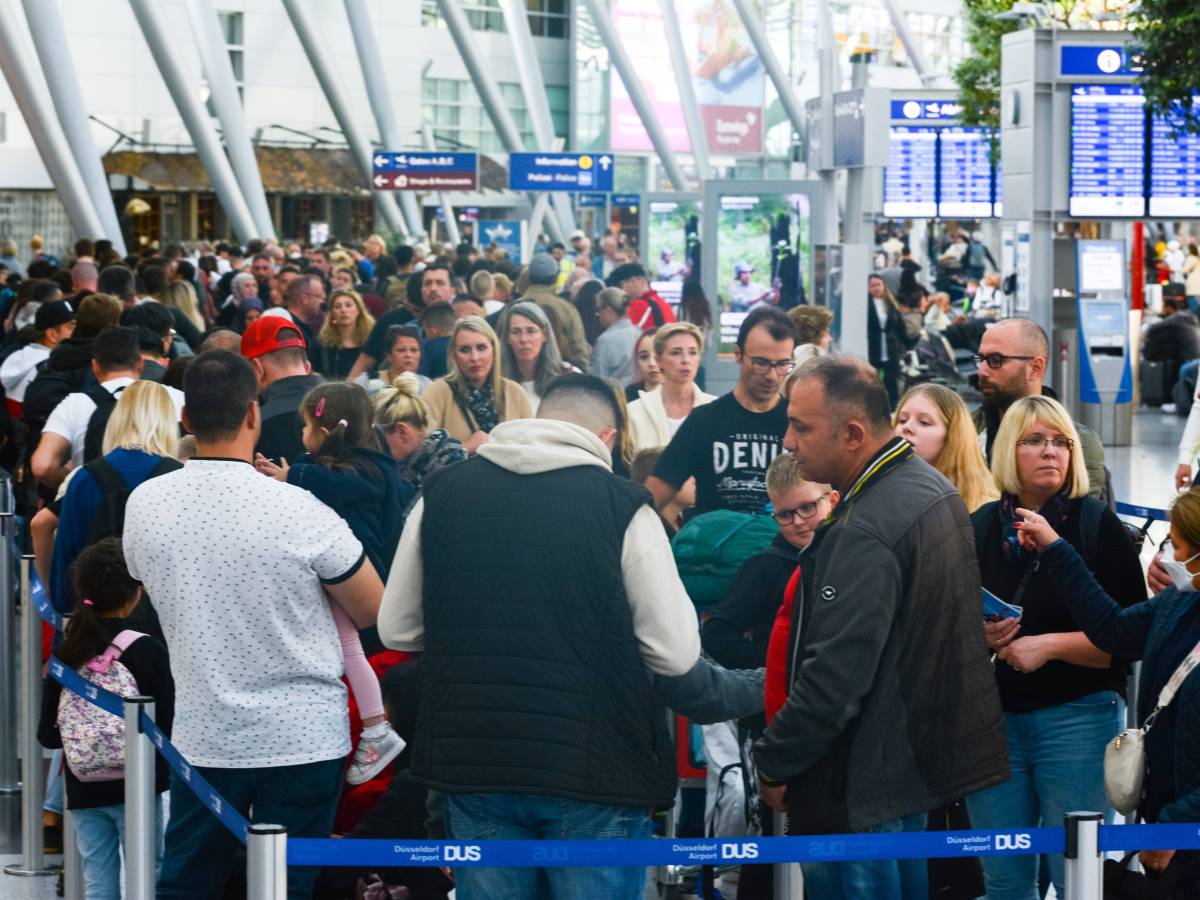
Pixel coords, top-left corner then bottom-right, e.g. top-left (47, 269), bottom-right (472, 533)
top-left (124, 458), bottom-right (365, 769)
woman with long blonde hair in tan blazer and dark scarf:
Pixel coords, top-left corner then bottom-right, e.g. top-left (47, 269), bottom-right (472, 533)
top-left (425, 316), bottom-right (533, 454)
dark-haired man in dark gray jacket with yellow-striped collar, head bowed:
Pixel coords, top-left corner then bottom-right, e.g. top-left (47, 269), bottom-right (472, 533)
top-left (754, 356), bottom-right (1009, 900)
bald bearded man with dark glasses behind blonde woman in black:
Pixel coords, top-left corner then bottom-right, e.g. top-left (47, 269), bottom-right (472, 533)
top-left (971, 317), bottom-right (1111, 503)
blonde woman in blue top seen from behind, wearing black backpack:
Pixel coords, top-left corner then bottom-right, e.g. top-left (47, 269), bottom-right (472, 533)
top-left (50, 382), bottom-right (181, 624)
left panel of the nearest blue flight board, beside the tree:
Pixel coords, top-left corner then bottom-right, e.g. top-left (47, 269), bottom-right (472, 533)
top-left (1068, 84), bottom-right (1146, 217)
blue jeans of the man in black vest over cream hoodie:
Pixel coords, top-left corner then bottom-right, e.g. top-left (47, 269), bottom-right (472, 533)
top-left (446, 793), bottom-right (650, 900)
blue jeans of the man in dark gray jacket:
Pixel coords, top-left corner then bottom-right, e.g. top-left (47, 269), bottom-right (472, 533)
top-left (800, 812), bottom-right (929, 900)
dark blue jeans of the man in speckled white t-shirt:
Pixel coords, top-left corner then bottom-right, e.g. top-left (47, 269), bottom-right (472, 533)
top-left (158, 758), bottom-right (343, 900)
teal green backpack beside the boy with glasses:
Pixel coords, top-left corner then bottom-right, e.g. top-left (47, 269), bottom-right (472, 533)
top-left (671, 509), bottom-right (779, 611)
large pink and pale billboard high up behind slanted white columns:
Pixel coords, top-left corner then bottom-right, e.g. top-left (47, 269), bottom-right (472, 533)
top-left (608, 0), bottom-right (766, 154)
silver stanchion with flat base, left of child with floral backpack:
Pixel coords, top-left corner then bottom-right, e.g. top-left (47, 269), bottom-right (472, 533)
top-left (4, 556), bottom-right (58, 875)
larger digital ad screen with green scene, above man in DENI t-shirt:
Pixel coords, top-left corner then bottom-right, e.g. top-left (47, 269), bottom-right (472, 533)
top-left (709, 193), bottom-right (812, 356)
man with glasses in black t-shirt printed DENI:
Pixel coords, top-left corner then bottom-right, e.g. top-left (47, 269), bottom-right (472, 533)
top-left (646, 306), bottom-right (797, 515)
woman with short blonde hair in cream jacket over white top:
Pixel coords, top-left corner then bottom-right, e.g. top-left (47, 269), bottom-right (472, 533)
top-left (629, 322), bottom-right (716, 450)
